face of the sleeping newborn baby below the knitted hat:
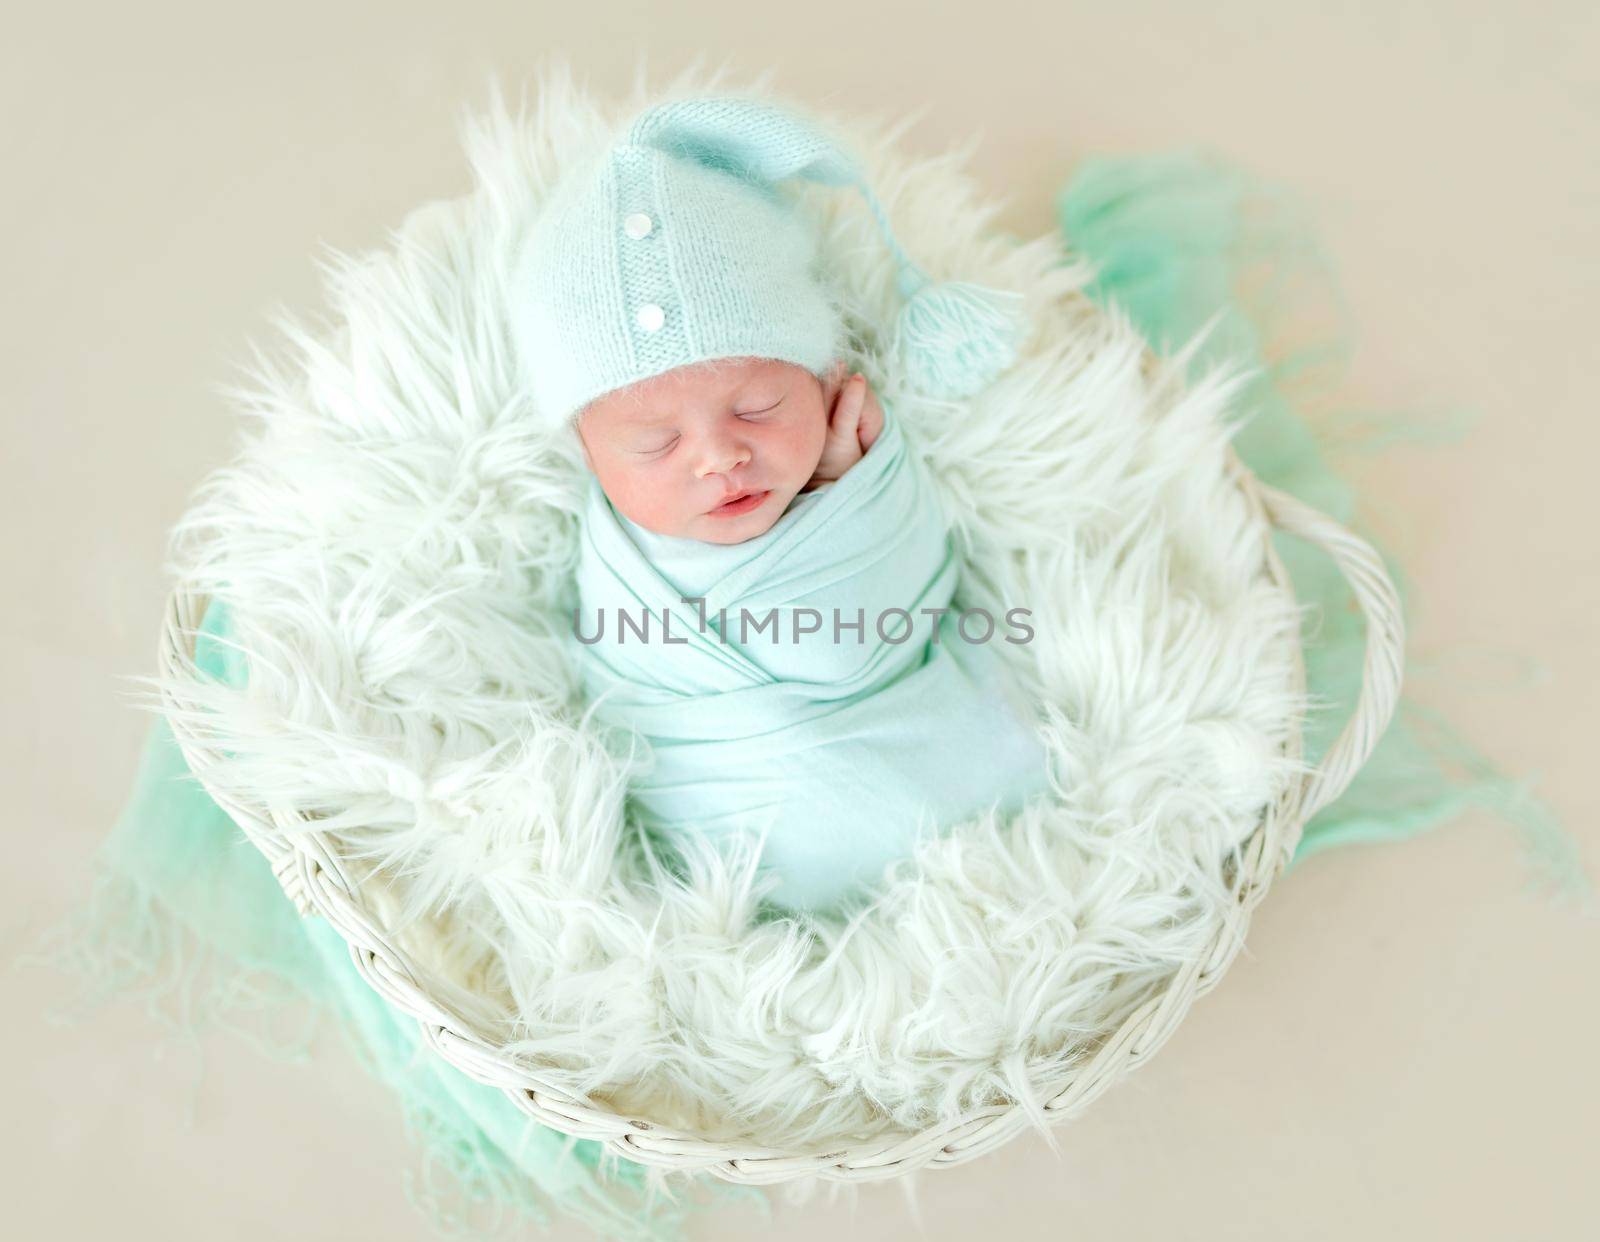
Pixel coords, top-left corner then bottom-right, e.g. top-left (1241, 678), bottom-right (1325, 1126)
top-left (578, 359), bottom-right (827, 544)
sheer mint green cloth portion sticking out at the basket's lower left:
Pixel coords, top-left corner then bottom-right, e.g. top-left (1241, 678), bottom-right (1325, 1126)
top-left (31, 602), bottom-right (768, 1242)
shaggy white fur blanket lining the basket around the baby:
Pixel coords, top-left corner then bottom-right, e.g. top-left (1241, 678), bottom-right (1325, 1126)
top-left (162, 70), bottom-right (1304, 1149)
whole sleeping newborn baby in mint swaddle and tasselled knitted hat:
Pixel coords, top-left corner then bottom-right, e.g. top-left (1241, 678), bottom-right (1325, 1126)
top-left (506, 96), bottom-right (1048, 911)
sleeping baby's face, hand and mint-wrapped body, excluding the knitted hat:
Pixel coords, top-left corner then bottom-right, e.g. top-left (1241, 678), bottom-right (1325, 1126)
top-left (574, 359), bottom-right (1048, 911)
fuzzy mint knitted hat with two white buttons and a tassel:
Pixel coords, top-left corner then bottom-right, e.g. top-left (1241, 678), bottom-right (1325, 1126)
top-left (510, 96), bottom-right (1027, 426)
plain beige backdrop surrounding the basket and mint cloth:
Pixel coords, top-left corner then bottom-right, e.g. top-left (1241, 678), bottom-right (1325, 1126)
top-left (0, 0), bottom-right (1600, 1242)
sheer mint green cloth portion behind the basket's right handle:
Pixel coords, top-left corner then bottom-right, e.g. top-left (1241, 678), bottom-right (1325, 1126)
top-left (1056, 149), bottom-right (1595, 899)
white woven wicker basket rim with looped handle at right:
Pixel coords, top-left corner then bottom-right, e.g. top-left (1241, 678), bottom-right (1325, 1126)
top-left (158, 451), bottom-right (1405, 1184)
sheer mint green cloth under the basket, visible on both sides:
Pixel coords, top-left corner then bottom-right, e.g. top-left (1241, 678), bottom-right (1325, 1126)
top-left (31, 152), bottom-right (1592, 1239)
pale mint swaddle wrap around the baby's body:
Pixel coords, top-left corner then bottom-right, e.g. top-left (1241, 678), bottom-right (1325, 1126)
top-left (574, 395), bottom-right (1048, 911)
